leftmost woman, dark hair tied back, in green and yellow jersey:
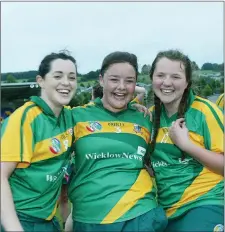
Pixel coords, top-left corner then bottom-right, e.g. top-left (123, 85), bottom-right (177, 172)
top-left (1, 52), bottom-right (77, 232)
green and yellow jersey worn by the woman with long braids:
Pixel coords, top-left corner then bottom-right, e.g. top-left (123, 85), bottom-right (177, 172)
top-left (151, 92), bottom-right (224, 218)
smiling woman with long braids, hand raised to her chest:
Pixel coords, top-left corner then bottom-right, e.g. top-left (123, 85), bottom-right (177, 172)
top-left (150, 50), bottom-right (224, 232)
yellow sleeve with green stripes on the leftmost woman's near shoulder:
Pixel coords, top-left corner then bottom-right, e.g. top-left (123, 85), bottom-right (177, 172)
top-left (1, 102), bottom-right (33, 163)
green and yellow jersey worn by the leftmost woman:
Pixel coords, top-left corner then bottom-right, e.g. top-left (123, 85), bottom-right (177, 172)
top-left (1, 97), bottom-right (73, 220)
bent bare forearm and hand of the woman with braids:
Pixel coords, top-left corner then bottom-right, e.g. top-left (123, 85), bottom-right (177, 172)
top-left (169, 118), bottom-right (224, 176)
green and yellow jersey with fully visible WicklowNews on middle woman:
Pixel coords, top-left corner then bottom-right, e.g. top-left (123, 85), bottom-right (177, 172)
top-left (69, 98), bottom-right (157, 224)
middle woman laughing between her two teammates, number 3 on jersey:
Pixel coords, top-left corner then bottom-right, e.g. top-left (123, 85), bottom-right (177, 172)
top-left (66, 52), bottom-right (167, 232)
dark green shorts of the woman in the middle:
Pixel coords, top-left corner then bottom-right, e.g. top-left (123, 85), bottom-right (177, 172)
top-left (73, 207), bottom-right (168, 232)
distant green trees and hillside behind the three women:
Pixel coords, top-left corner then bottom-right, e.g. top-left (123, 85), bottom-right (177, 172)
top-left (2, 62), bottom-right (224, 106)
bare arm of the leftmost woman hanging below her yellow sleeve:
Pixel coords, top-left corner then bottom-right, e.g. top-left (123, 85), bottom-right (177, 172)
top-left (1, 162), bottom-right (24, 231)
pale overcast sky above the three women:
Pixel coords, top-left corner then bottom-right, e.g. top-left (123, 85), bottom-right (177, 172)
top-left (1, 2), bottom-right (224, 74)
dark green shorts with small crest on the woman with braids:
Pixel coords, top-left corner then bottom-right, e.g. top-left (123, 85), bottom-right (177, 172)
top-left (165, 205), bottom-right (224, 232)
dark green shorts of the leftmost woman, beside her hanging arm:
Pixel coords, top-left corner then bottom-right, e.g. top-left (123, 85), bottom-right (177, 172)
top-left (1, 213), bottom-right (61, 232)
